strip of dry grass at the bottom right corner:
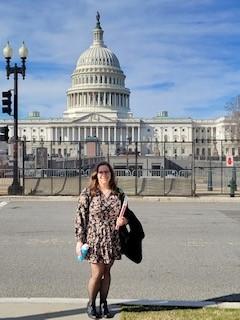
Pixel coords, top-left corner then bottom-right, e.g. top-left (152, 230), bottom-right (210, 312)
top-left (120, 306), bottom-right (240, 320)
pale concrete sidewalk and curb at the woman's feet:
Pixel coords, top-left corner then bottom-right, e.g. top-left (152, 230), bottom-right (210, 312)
top-left (0, 298), bottom-right (240, 320)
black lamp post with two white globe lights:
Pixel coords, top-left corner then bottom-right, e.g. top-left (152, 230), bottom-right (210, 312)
top-left (3, 42), bottom-right (28, 195)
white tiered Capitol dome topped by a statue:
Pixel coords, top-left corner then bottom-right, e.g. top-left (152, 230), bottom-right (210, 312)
top-left (64, 13), bottom-right (130, 118)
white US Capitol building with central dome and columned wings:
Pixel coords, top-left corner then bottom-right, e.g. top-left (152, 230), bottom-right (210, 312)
top-left (0, 14), bottom-right (236, 168)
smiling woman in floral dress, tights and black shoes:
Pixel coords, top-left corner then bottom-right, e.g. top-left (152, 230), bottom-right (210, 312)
top-left (75, 162), bottom-right (128, 319)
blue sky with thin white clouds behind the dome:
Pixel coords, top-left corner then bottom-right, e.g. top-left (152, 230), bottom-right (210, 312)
top-left (0, 0), bottom-right (240, 119)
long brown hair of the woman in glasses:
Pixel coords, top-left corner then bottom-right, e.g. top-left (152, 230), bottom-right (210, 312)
top-left (88, 161), bottom-right (117, 196)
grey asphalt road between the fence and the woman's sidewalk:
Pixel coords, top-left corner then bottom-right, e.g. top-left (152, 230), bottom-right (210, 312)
top-left (0, 198), bottom-right (240, 301)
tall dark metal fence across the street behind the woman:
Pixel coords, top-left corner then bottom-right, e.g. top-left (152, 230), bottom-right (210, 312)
top-left (0, 138), bottom-right (240, 196)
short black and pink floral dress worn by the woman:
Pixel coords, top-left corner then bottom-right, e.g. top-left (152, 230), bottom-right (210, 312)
top-left (75, 188), bottom-right (121, 264)
